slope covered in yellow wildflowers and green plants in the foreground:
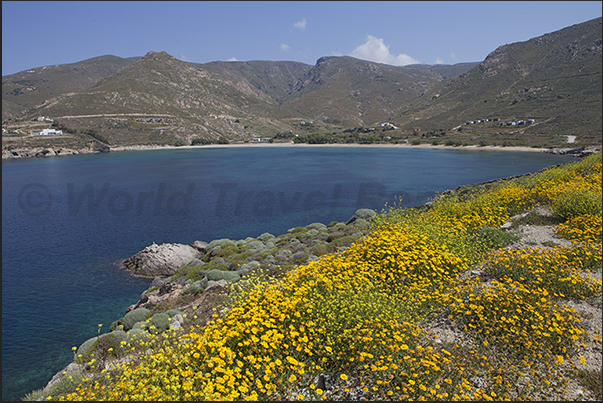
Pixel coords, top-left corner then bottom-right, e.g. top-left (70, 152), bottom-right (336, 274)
top-left (35, 153), bottom-right (602, 400)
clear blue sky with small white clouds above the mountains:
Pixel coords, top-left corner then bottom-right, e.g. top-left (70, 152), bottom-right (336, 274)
top-left (2, 1), bottom-right (602, 76)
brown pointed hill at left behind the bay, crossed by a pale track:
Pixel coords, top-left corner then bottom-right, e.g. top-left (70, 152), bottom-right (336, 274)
top-left (15, 51), bottom-right (302, 144)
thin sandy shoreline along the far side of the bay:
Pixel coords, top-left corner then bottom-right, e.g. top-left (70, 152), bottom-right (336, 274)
top-left (2, 142), bottom-right (601, 160)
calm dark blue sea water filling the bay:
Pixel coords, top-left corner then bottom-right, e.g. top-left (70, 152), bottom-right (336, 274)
top-left (2, 147), bottom-right (571, 400)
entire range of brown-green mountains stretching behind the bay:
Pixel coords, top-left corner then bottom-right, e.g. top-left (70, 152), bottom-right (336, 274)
top-left (2, 18), bottom-right (602, 147)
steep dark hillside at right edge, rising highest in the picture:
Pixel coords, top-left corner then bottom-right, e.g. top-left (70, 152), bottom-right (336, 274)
top-left (392, 18), bottom-right (602, 144)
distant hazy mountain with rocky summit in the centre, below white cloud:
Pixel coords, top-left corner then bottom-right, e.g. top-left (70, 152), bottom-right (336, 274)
top-left (283, 56), bottom-right (472, 127)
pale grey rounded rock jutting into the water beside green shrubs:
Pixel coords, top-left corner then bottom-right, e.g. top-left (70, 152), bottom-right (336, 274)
top-left (124, 243), bottom-right (202, 278)
